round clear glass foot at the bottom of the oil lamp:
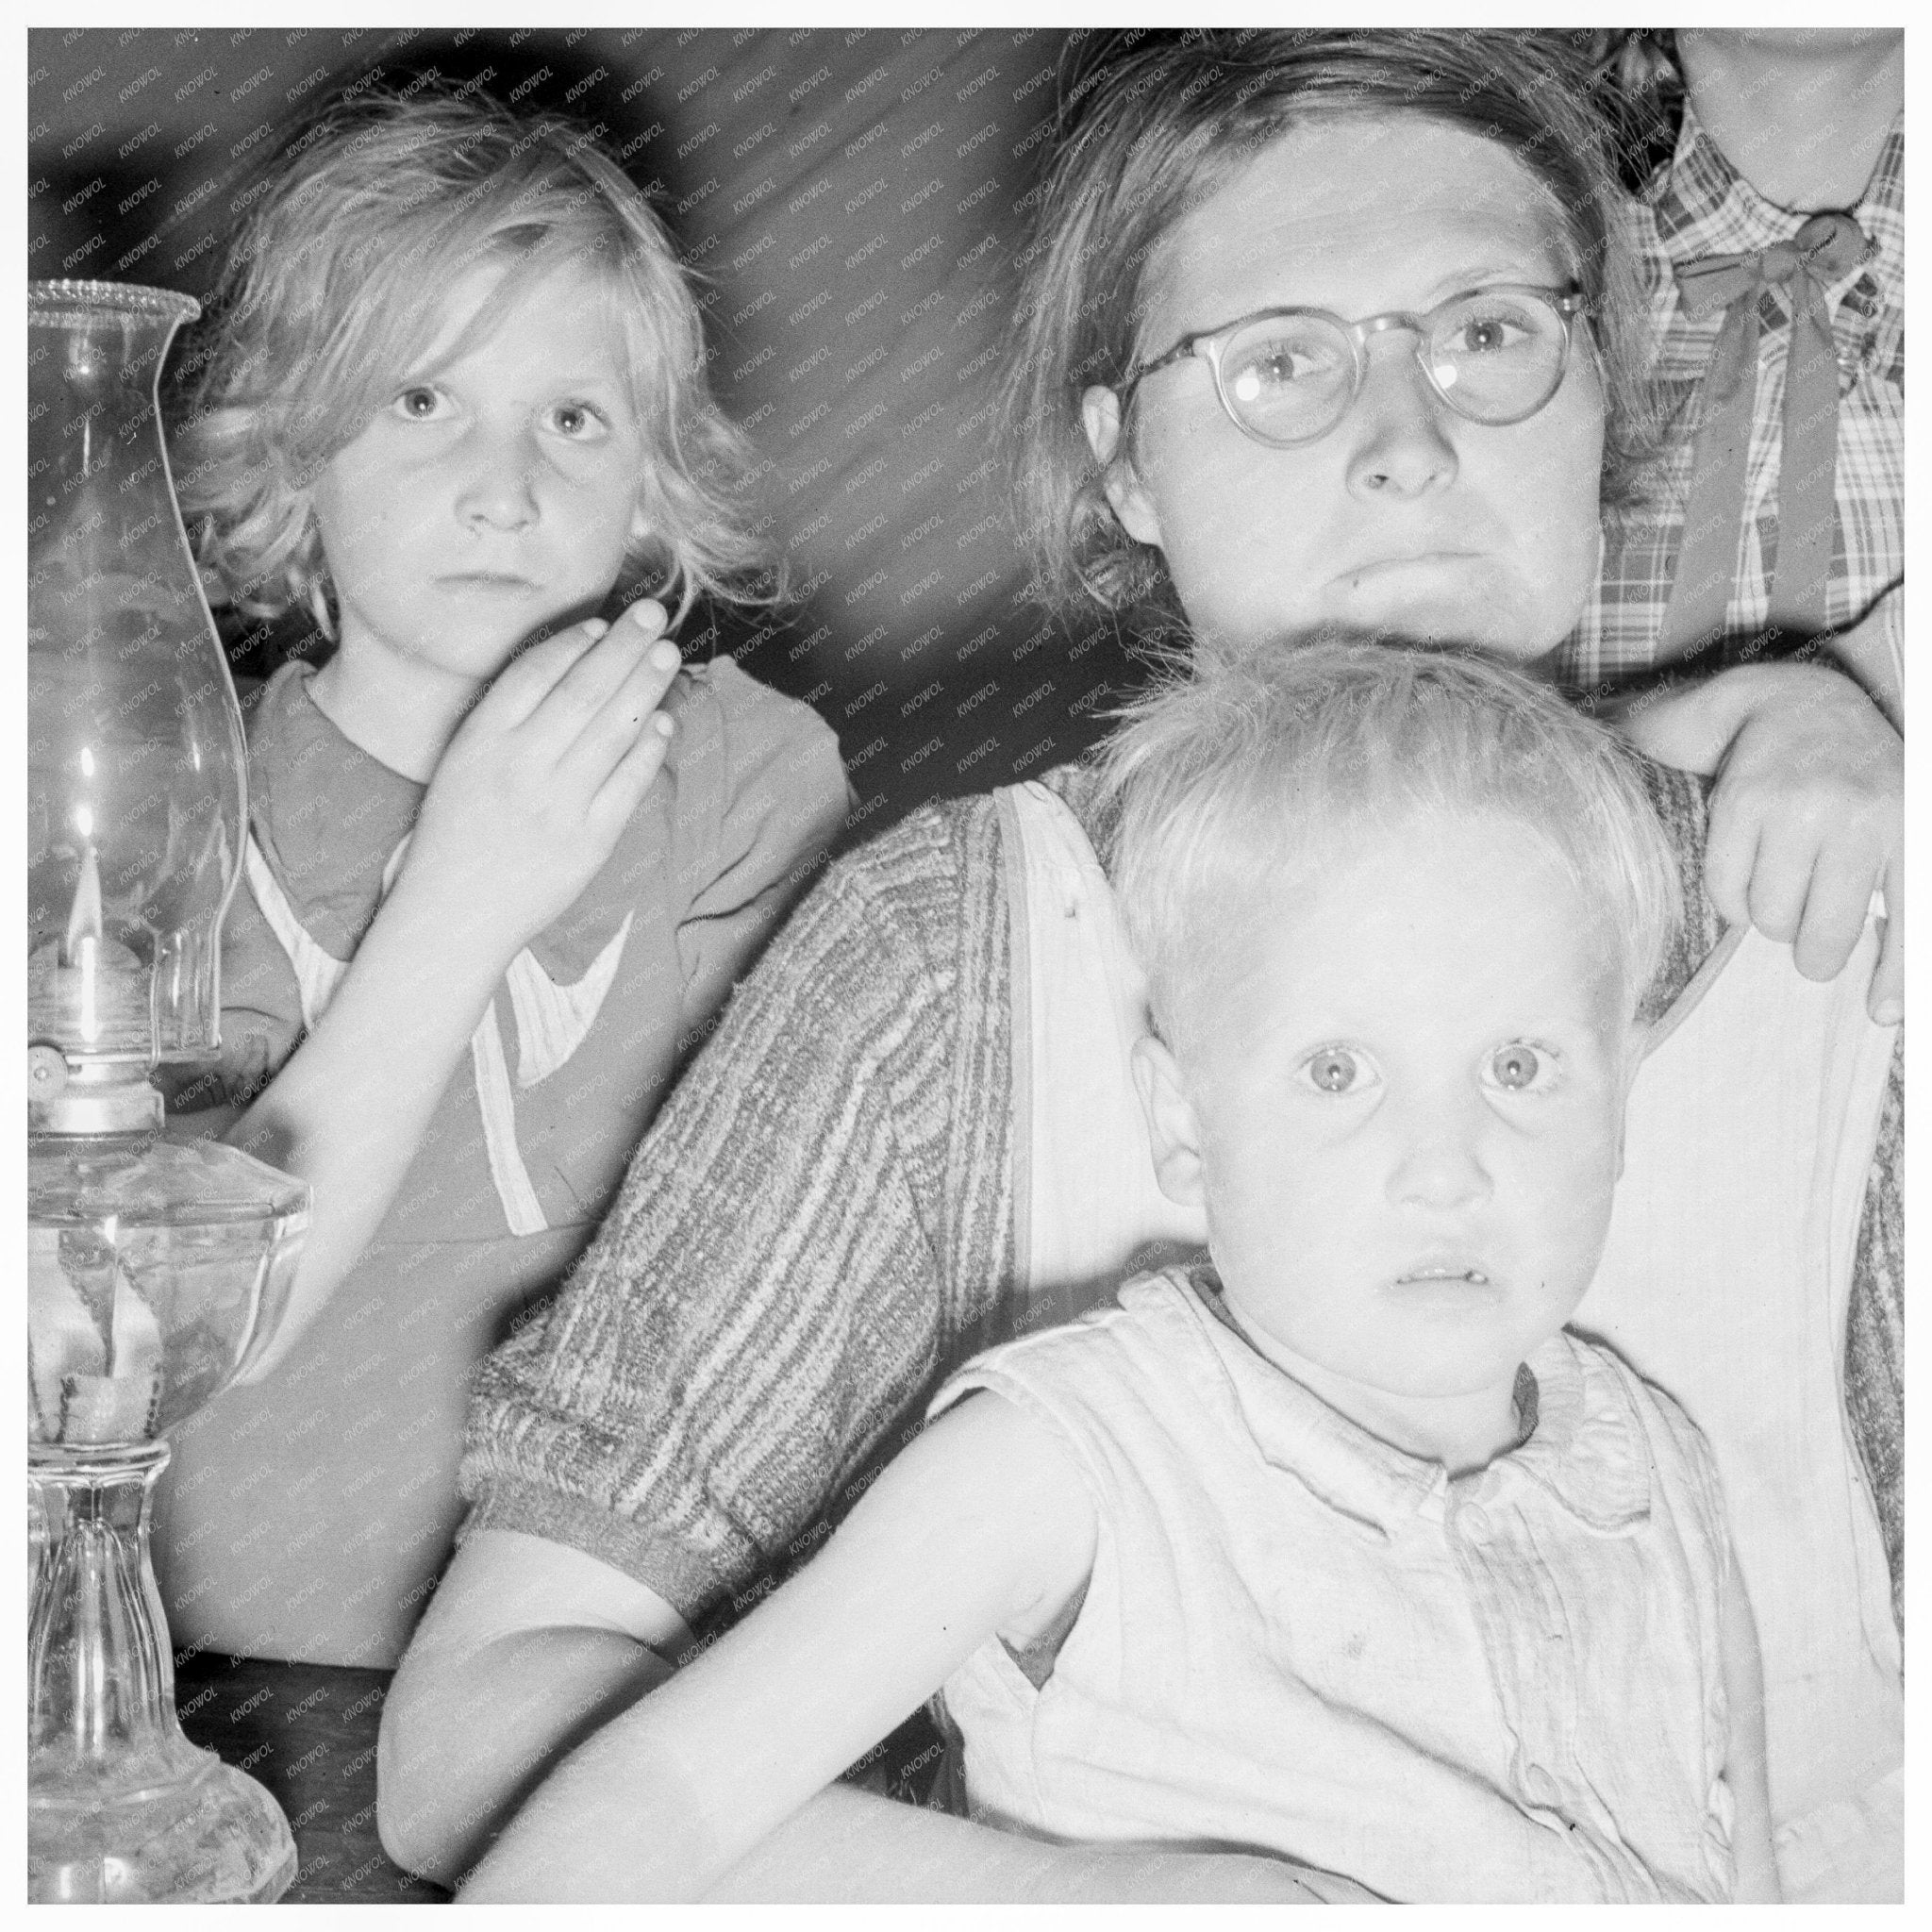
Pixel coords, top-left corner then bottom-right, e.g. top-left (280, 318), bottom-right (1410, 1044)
top-left (27, 1744), bottom-right (295, 1905)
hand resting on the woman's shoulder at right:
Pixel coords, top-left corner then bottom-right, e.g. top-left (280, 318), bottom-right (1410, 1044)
top-left (1617, 665), bottom-right (1905, 1025)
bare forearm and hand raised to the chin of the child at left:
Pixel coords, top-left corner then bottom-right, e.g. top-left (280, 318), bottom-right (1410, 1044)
top-left (223, 605), bottom-right (676, 1379)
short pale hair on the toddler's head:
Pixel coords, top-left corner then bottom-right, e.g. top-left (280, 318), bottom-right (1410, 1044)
top-left (1101, 634), bottom-right (1683, 1038)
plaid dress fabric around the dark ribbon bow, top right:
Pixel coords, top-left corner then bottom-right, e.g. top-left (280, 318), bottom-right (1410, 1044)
top-left (1557, 103), bottom-right (1905, 690)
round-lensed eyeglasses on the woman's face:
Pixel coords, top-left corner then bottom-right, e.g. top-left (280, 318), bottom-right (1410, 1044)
top-left (1121, 282), bottom-right (1582, 450)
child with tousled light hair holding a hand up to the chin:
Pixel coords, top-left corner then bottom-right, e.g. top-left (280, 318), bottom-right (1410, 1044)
top-left (160, 92), bottom-right (848, 1663)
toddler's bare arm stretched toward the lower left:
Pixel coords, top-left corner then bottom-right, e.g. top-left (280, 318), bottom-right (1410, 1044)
top-left (444, 1397), bottom-right (1093, 1901)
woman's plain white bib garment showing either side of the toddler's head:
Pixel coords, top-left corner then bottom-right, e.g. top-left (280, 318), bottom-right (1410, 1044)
top-left (997, 782), bottom-right (1905, 1903)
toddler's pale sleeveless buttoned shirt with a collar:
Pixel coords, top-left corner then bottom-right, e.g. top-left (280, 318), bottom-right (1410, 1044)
top-left (935, 1270), bottom-right (1735, 1903)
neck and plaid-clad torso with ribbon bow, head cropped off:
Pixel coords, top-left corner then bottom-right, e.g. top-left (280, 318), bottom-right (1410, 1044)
top-left (1584, 27), bottom-right (1905, 730)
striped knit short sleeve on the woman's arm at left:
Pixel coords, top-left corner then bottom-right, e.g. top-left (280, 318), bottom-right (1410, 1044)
top-left (459, 800), bottom-right (1012, 1619)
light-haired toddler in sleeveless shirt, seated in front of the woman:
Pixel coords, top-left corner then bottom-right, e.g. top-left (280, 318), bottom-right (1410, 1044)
top-left (498, 641), bottom-right (1777, 1901)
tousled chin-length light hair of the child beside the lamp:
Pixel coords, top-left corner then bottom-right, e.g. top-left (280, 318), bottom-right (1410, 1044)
top-left (174, 89), bottom-right (774, 632)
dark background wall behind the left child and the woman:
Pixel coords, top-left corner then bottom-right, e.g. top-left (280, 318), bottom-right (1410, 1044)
top-left (27, 27), bottom-right (1134, 837)
